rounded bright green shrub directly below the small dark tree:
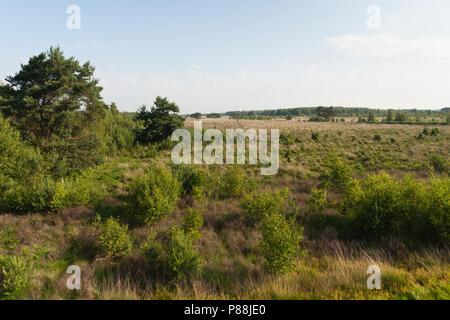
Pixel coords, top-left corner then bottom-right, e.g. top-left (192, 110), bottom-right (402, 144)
top-left (128, 167), bottom-right (181, 224)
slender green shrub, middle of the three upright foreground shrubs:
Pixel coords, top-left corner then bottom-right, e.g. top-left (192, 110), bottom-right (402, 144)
top-left (165, 226), bottom-right (202, 280)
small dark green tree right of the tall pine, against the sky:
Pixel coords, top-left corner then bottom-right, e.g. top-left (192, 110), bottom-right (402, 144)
top-left (135, 97), bottom-right (184, 144)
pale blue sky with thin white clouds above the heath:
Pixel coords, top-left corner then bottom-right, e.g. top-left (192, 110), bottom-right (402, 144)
top-left (0, 0), bottom-right (450, 114)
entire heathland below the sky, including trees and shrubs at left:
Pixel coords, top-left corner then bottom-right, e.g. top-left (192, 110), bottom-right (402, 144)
top-left (0, 48), bottom-right (450, 299)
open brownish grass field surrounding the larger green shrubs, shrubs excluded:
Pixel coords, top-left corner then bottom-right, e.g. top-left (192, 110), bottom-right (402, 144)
top-left (0, 119), bottom-right (450, 299)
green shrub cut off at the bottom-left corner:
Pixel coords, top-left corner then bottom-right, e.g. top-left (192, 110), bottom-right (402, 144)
top-left (0, 255), bottom-right (33, 300)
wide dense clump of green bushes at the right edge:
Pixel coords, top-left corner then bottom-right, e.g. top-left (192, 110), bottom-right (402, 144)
top-left (345, 173), bottom-right (450, 243)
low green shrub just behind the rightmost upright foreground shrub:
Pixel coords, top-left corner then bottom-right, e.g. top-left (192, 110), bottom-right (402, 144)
top-left (242, 188), bottom-right (289, 223)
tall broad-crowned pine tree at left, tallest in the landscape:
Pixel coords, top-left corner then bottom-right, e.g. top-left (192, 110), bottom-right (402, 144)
top-left (0, 47), bottom-right (105, 146)
